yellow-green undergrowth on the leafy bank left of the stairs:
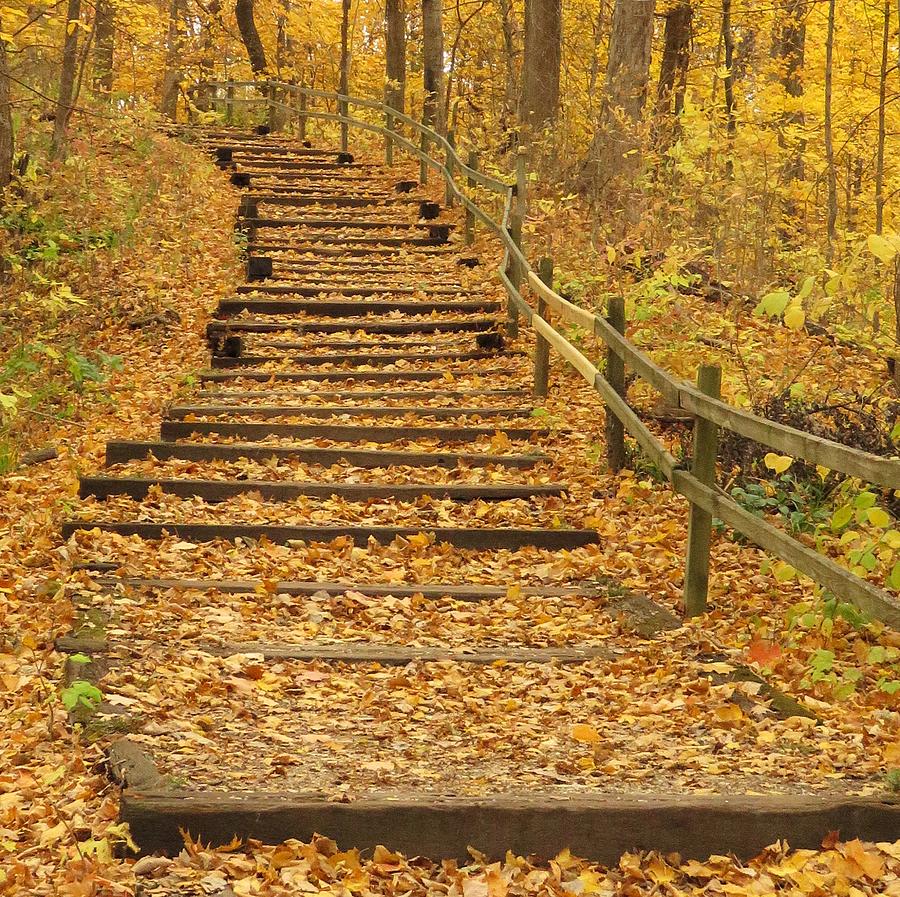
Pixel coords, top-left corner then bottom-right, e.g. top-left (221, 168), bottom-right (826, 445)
top-left (0, 107), bottom-right (229, 473)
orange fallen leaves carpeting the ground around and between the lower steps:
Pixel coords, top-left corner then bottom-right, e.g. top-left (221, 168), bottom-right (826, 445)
top-left (0, 121), bottom-right (900, 897)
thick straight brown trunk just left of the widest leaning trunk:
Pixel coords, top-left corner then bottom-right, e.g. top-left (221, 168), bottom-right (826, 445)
top-left (519, 0), bottom-right (562, 133)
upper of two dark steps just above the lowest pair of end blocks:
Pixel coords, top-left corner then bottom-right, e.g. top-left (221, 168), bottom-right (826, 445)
top-left (216, 298), bottom-right (501, 318)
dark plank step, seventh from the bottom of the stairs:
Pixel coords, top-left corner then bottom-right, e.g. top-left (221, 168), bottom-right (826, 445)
top-left (159, 420), bottom-right (550, 443)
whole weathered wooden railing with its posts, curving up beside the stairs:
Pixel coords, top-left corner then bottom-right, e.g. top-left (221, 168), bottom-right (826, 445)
top-left (206, 81), bottom-right (900, 628)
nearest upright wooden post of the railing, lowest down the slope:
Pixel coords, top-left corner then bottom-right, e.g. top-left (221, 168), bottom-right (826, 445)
top-left (684, 365), bottom-right (722, 617)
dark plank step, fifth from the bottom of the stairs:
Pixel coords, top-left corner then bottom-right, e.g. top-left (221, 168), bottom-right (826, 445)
top-left (78, 476), bottom-right (565, 502)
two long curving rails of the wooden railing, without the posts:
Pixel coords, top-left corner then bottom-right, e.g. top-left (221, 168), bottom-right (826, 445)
top-left (197, 81), bottom-right (900, 629)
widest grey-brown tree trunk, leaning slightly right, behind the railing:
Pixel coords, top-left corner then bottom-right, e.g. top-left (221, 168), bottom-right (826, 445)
top-left (585, 0), bottom-right (655, 188)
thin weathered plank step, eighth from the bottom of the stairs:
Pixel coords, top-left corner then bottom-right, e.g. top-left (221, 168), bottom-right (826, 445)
top-left (167, 404), bottom-right (532, 420)
